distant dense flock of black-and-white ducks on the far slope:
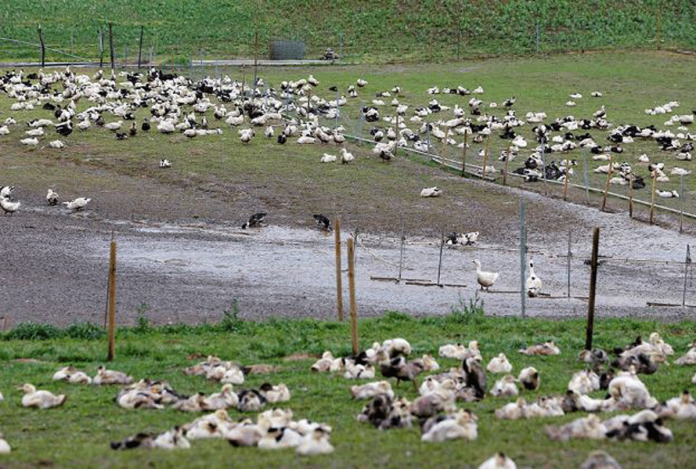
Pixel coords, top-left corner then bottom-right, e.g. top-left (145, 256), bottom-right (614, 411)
top-left (0, 67), bottom-right (696, 221)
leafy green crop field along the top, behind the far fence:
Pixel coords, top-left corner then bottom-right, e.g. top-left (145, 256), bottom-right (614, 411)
top-left (0, 0), bottom-right (696, 63)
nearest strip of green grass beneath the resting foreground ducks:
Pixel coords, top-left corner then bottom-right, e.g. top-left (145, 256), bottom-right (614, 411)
top-left (0, 308), bottom-right (696, 468)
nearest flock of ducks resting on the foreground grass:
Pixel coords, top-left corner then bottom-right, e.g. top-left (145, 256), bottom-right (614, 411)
top-left (0, 332), bottom-right (696, 469)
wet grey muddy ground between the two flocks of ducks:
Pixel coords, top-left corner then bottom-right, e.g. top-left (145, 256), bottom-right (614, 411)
top-left (0, 155), bottom-right (696, 327)
